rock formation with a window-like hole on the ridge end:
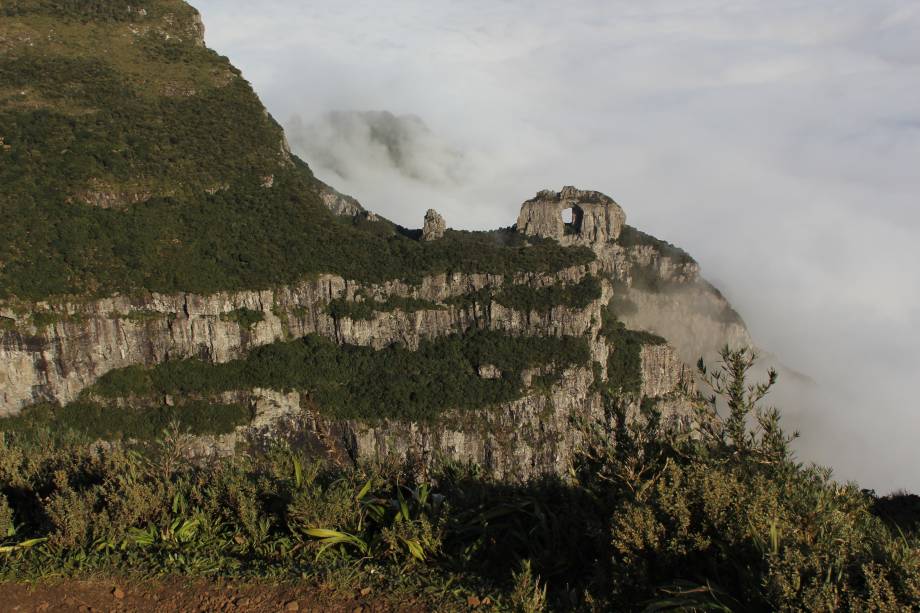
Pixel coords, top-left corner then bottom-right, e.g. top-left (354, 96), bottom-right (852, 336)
top-left (517, 186), bottom-right (626, 246)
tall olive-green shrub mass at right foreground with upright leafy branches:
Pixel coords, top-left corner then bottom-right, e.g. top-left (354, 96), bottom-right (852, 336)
top-left (579, 349), bottom-right (920, 611)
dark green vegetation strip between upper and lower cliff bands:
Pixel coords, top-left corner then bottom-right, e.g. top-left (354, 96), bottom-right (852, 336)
top-left (84, 331), bottom-right (589, 420)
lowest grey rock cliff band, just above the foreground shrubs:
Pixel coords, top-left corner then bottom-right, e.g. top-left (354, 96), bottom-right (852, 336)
top-left (185, 338), bottom-right (692, 482)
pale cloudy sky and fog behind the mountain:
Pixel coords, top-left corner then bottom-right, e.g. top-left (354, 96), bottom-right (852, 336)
top-left (193, 0), bottom-right (920, 492)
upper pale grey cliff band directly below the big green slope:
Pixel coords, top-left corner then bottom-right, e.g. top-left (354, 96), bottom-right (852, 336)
top-left (0, 267), bottom-right (602, 416)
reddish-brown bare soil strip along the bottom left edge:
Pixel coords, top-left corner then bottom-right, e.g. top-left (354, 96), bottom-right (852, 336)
top-left (0, 581), bottom-right (427, 613)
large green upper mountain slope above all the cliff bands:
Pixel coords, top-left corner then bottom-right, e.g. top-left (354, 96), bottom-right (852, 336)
top-left (0, 0), bottom-right (594, 300)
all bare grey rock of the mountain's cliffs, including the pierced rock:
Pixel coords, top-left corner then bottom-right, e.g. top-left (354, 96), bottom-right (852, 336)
top-left (0, 188), bottom-right (750, 479)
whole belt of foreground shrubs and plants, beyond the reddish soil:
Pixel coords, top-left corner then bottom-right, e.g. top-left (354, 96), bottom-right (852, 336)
top-left (0, 352), bottom-right (920, 613)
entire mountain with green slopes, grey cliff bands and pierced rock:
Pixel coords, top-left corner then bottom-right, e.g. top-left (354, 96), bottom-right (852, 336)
top-left (0, 0), bottom-right (750, 479)
